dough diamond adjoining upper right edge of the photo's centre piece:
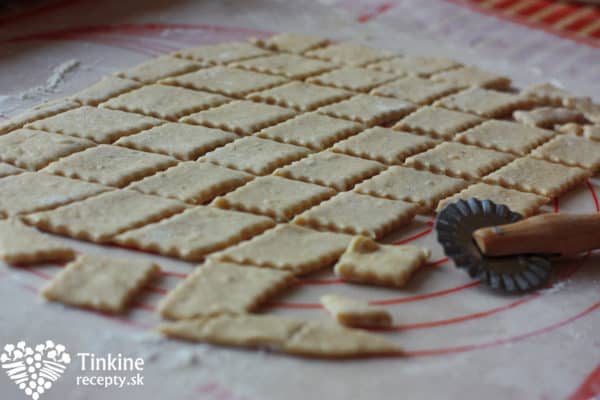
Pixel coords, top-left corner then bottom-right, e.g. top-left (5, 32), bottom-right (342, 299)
top-left (273, 151), bottom-right (385, 191)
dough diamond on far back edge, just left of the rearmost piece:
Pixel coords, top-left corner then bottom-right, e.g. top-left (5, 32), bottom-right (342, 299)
top-left (175, 42), bottom-right (272, 64)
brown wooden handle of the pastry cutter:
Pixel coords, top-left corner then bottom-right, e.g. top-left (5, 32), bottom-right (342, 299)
top-left (473, 214), bottom-right (600, 256)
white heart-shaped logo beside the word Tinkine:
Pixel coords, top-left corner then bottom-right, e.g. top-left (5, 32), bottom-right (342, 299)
top-left (0, 340), bottom-right (71, 400)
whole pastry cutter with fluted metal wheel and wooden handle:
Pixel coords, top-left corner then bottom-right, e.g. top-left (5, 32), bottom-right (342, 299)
top-left (435, 198), bottom-right (600, 293)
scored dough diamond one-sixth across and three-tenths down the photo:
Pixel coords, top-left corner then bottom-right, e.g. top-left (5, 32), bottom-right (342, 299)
top-left (25, 106), bottom-right (162, 143)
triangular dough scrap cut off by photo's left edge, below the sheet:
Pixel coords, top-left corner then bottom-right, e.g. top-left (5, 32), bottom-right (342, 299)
top-left (0, 219), bottom-right (75, 264)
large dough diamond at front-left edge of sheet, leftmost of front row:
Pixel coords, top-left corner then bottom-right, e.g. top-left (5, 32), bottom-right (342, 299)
top-left (23, 190), bottom-right (186, 243)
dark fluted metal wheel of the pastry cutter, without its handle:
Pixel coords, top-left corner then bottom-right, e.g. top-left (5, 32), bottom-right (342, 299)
top-left (435, 198), bottom-right (552, 293)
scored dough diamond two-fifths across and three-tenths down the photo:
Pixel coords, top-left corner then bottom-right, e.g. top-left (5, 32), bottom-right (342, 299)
top-left (180, 100), bottom-right (296, 135)
